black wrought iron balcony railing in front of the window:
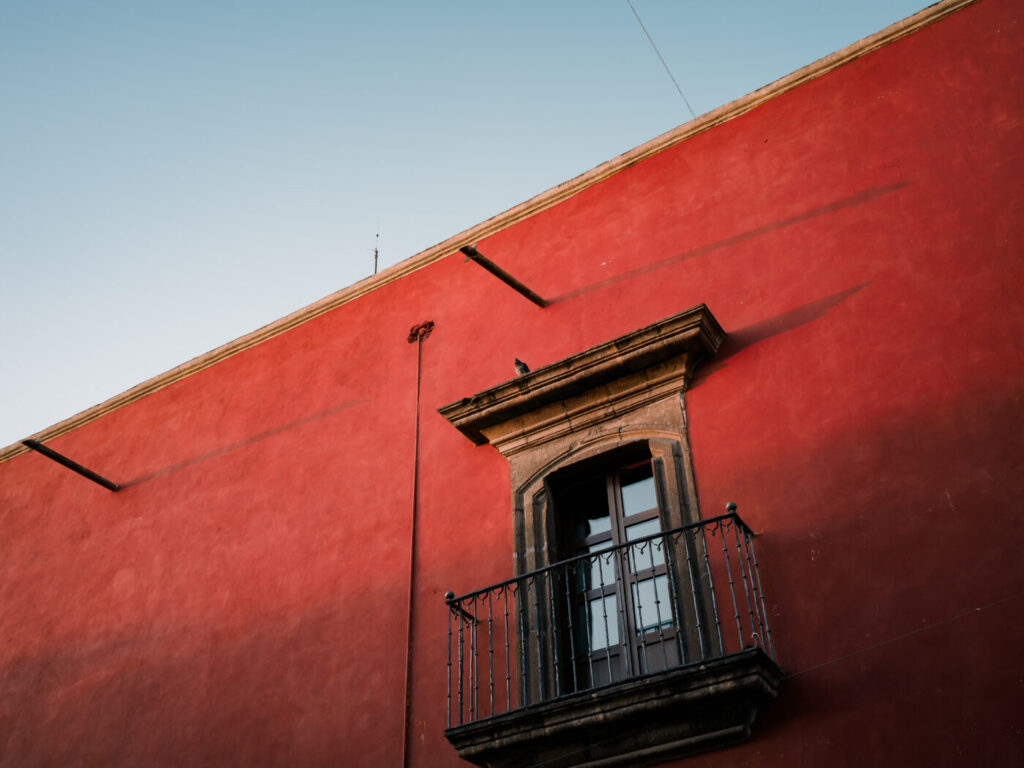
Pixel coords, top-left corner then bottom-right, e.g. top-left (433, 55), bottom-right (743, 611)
top-left (445, 504), bottom-right (775, 728)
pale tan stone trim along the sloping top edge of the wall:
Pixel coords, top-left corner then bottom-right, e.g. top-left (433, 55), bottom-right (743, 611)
top-left (0, 0), bottom-right (976, 462)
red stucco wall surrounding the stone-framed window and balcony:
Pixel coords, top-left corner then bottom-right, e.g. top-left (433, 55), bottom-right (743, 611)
top-left (0, 0), bottom-right (1024, 766)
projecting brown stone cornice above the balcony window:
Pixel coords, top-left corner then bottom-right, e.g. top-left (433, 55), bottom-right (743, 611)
top-left (439, 304), bottom-right (725, 456)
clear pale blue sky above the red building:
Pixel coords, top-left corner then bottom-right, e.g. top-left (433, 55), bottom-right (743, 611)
top-left (0, 0), bottom-right (926, 446)
